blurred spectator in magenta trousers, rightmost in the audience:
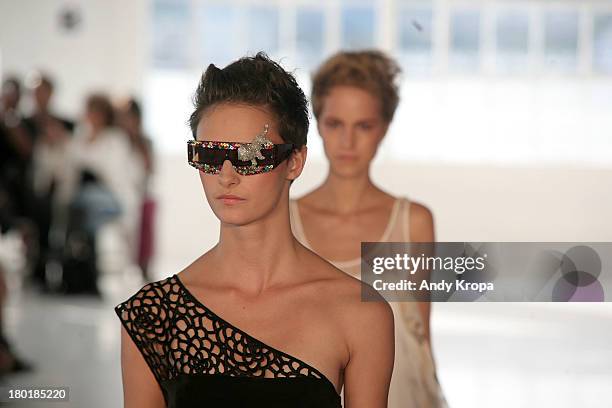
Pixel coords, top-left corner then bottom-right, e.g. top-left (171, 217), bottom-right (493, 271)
top-left (117, 98), bottom-right (156, 281)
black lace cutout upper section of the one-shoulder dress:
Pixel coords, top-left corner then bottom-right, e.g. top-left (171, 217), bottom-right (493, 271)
top-left (115, 275), bottom-right (336, 393)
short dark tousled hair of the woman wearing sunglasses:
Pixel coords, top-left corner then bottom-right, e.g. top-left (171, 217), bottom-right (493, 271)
top-left (189, 52), bottom-right (309, 148)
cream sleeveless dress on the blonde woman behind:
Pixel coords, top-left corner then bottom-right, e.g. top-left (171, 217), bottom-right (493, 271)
top-left (289, 197), bottom-right (447, 408)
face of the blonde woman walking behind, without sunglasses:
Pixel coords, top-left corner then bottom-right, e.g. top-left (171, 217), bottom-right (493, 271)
top-left (318, 86), bottom-right (388, 177)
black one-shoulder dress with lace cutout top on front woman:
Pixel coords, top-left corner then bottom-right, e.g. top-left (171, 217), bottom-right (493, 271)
top-left (115, 274), bottom-right (341, 408)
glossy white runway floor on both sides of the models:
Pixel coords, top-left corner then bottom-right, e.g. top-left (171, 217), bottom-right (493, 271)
top-left (0, 270), bottom-right (612, 408)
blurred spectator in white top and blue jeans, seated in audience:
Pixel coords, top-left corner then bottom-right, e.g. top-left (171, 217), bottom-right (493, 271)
top-left (59, 94), bottom-right (145, 293)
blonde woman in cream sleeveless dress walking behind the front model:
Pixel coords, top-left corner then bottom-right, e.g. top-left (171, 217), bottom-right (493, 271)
top-left (290, 51), bottom-right (446, 408)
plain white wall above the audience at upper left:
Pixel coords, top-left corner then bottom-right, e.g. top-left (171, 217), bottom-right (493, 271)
top-left (0, 0), bottom-right (149, 117)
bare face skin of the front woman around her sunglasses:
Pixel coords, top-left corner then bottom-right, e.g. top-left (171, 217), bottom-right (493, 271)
top-left (196, 104), bottom-right (305, 225)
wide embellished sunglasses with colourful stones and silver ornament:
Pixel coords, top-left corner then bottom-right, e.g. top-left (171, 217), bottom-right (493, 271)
top-left (187, 124), bottom-right (294, 176)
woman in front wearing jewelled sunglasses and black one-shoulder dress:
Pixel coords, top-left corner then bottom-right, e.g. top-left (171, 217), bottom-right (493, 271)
top-left (115, 53), bottom-right (394, 408)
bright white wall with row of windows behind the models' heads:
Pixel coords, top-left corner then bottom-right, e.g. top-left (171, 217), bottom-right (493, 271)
top-left (143, 0), bottom-right (612, 167)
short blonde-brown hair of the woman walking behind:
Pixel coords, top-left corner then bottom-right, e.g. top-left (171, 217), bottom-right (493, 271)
top-left (311, 50), bottom-right (401, 122)
